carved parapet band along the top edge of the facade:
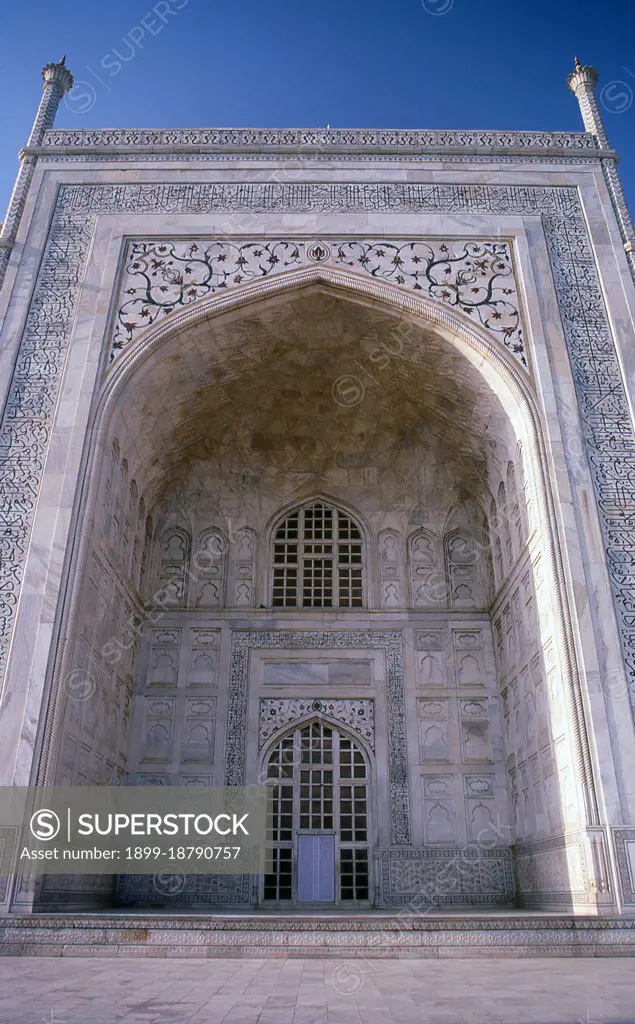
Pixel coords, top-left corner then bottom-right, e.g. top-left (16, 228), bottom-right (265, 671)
top-left (38, 128), bottom-right (598, 157)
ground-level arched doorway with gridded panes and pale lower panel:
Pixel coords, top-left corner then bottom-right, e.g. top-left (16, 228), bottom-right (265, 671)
top-left (262, 720), bottom-right (372, 907)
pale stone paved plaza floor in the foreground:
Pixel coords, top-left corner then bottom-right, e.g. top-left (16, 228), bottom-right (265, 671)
top-left (0, 956), bottom-right (635, 1024)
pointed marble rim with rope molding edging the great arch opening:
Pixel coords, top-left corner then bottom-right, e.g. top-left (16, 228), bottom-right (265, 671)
top-left (34, 267), bottom-right (597, 913)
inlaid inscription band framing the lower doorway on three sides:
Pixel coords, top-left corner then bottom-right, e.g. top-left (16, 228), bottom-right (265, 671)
top-left (224, 630), bottom-right (410, 846)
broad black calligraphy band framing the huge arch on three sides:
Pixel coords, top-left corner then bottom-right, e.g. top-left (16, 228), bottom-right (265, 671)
top-left (0, 178), bottom-right (635, 737)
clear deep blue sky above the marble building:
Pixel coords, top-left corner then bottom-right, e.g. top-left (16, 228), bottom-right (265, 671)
top-left (0, 0), bottom-right (635, 210)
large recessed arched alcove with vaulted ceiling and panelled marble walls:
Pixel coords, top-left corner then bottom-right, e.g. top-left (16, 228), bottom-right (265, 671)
top-left (29, 270), bottom-right (595, 905)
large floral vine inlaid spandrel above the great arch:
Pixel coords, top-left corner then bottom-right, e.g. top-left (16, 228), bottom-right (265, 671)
top-left (110, 239), bottom-right (527, 370)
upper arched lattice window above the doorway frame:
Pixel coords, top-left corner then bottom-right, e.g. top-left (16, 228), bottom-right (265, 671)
top-left (272, 502), bottom-right (363, 608)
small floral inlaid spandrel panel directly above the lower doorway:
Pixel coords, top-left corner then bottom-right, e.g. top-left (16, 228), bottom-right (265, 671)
top-left (258, 697), bottom-right (375, 751)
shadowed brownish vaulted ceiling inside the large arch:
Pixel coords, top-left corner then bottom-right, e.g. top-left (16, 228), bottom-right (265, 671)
top-left (114, 286), bottom-right (511, 512)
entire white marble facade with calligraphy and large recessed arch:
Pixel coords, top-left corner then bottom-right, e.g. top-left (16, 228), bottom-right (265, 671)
top-left (0, 72), bottom-right (635, 915)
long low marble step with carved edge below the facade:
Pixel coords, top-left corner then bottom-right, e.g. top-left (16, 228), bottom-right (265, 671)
top-left (0, 910), bottom-right (635, 961)
